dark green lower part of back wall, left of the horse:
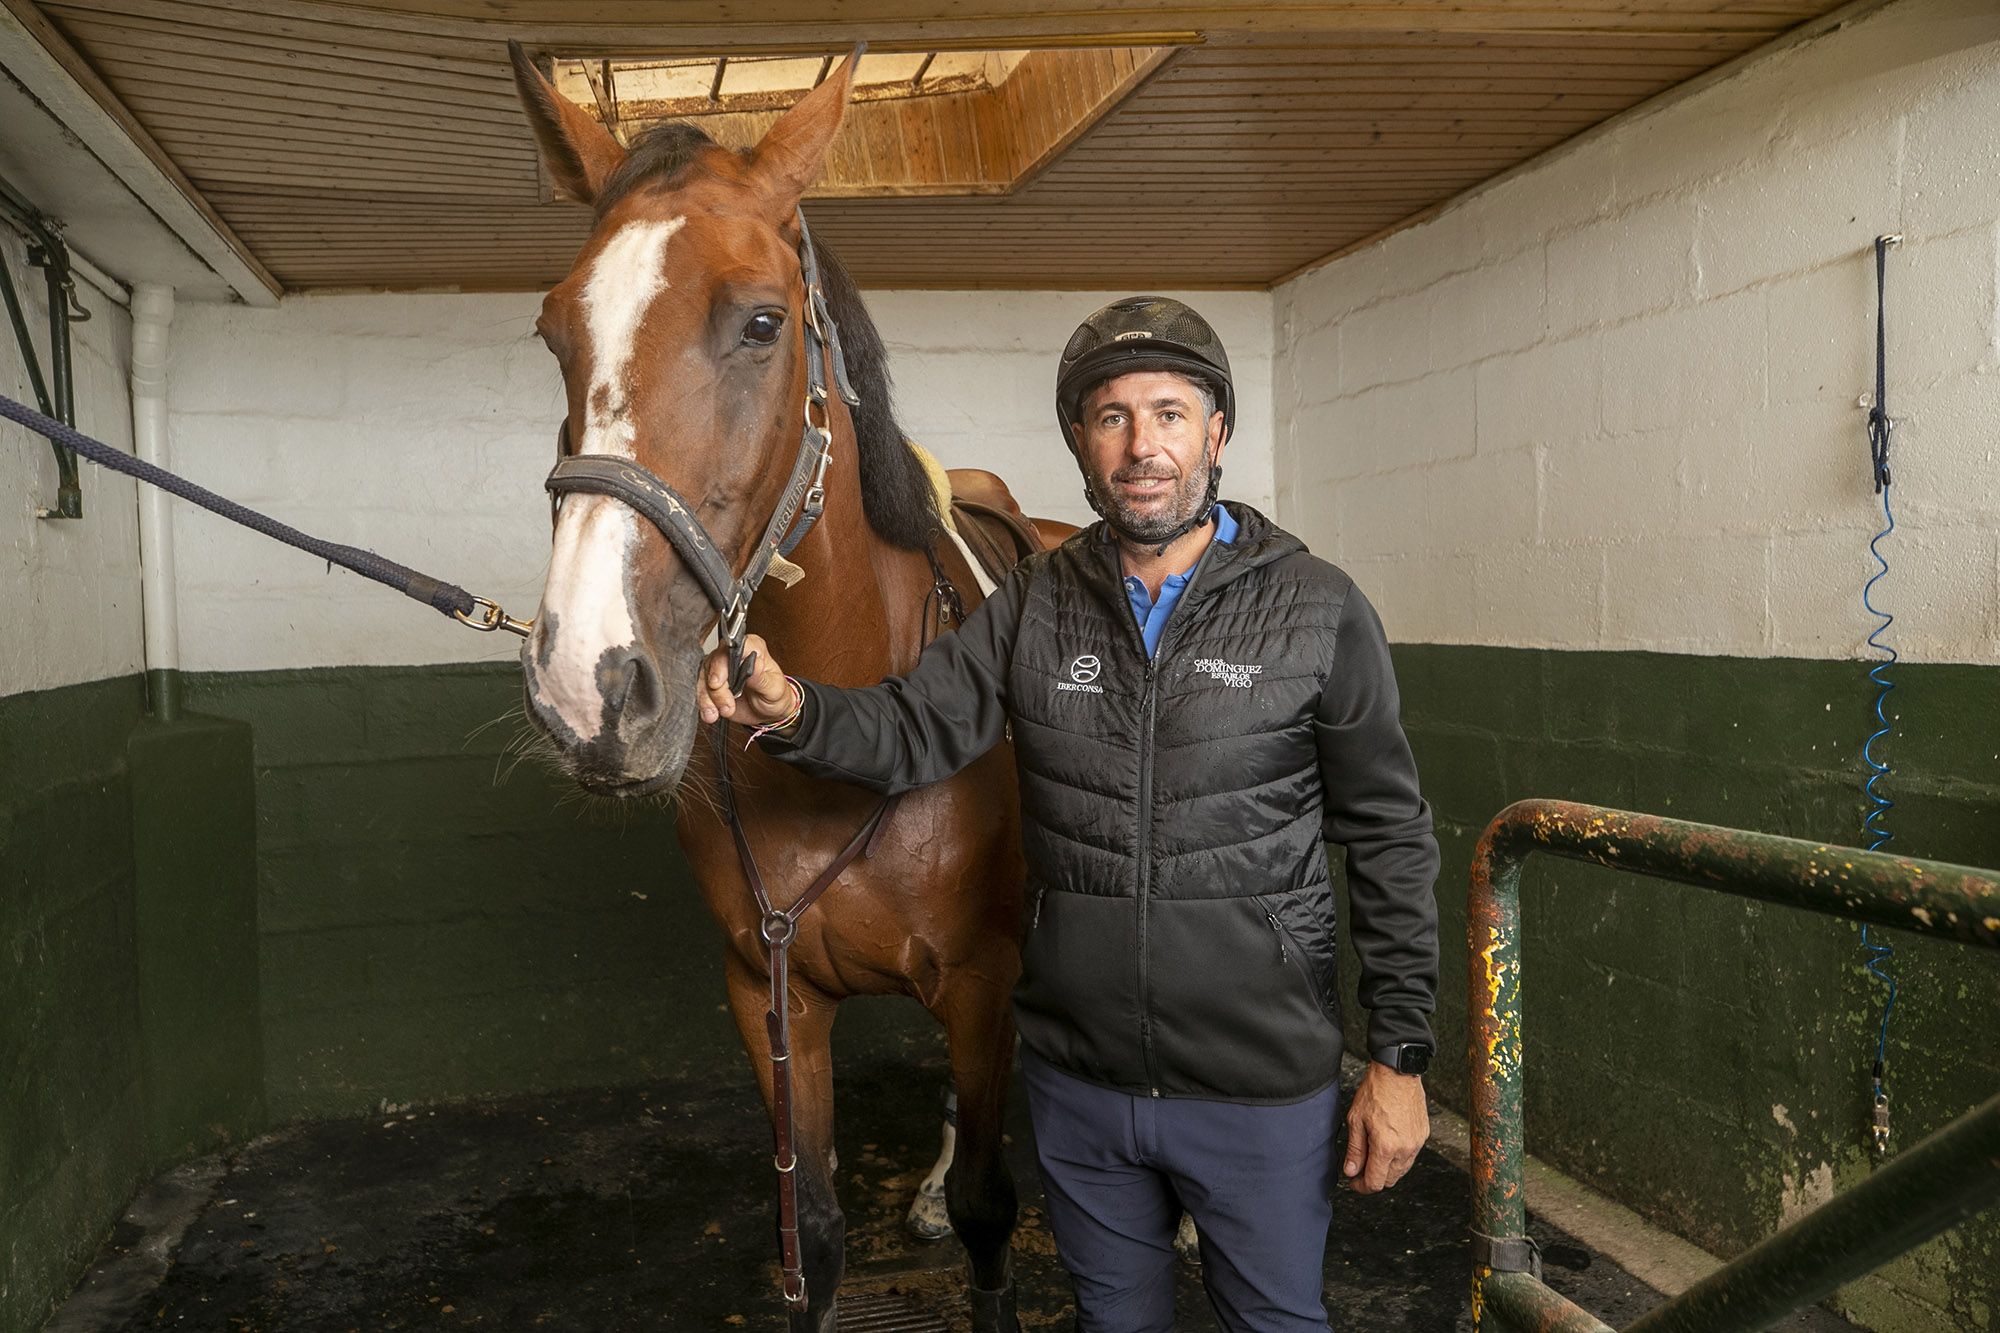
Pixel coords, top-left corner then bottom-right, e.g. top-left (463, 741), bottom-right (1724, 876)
top-left (172, 662), bottom-right (742, 1121)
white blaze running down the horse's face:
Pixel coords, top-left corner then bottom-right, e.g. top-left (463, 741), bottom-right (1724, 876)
top-left (532, 218), bottom-right (686, 743)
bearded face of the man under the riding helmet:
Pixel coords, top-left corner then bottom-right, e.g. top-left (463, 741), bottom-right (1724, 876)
top-left (1074, 370), bottom-right (1222, 542)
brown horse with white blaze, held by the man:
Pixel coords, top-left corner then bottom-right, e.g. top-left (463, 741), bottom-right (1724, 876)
top-left (514, 48), bottom-right (1048, 1333)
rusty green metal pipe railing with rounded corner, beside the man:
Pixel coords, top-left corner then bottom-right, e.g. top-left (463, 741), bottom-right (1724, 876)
top-left (1466, 801), bottom-right (2000, 1333)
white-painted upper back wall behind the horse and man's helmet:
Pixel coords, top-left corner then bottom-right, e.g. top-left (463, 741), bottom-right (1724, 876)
top-left (168, 292), bottom-right (1274, 671)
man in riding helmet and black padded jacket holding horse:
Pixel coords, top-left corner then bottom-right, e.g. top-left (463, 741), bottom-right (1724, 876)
top-left (700, 296), bottom-right (1438, 1333)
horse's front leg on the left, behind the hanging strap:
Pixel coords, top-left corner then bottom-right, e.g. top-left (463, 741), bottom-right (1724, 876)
top-left (728, 953), bottom-right (848, 1333)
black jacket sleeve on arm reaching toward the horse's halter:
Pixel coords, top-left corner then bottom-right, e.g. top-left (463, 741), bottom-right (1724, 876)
top-left (760, 566), bottom-right (1028, 795)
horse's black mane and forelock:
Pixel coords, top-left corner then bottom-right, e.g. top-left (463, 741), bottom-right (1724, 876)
top-left (596, 122), bottom-right (944, 550)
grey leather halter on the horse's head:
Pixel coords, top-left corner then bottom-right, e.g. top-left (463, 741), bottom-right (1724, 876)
top-left (544, 212), bottom-right (860, 693)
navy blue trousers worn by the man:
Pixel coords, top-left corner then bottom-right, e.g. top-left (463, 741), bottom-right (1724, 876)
top-left (1022, 1051), bottom-right (1340, 1333)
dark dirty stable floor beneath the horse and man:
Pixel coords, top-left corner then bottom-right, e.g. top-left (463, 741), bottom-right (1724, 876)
top-left (48, 1008), bottom-right (1850, 1333)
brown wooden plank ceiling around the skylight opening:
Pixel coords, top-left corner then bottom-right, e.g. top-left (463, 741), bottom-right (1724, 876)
top-left (23, 0), bottom-right (1834, 290)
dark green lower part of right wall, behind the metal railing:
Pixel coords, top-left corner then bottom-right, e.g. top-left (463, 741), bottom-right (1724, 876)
top-left (1394, 644), bottom-right (2000, 1331)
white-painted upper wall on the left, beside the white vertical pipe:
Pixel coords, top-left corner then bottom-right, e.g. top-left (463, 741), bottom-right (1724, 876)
top-left (0, 228), bottom-right (144, 696)
